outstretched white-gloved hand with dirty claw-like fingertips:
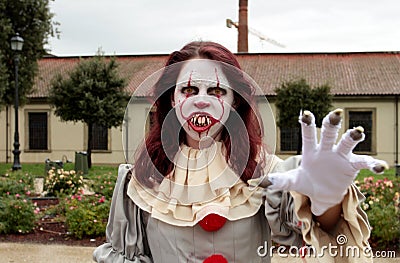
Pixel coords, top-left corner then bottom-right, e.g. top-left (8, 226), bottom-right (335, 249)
top-left (260, 109), bottom-right (388, 216)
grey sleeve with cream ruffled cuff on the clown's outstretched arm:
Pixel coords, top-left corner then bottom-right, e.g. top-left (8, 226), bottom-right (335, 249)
top-left (265, 156), bottom-right (372, 263)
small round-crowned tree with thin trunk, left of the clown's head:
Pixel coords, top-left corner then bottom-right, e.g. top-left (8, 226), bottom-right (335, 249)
top-left (49, 53), bottom-right (129, 168)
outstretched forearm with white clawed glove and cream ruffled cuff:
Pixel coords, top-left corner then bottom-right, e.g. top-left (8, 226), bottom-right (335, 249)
top-left (260, 110), bottom-right (388, 262)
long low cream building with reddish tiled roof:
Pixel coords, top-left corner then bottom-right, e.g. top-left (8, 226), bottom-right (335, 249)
top-left (0, 52), bottom-right (400, 166)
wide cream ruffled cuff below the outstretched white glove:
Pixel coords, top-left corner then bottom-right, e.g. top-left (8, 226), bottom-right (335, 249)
top-left (292, 185), bottom-right (373, 263)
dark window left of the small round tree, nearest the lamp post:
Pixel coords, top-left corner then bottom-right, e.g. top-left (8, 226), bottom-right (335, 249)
top-left (28, 112), bottom-right (48, 150)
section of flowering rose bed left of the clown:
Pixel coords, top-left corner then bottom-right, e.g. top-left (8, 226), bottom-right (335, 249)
top-left (0, 170), bottom-right (116, 249)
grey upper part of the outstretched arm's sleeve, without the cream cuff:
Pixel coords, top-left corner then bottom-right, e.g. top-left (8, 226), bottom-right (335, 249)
top-left (265, 156), bottom-right (303, 247)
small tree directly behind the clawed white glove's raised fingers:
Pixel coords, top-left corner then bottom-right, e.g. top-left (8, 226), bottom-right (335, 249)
top-left (275, 79), bottom-right (332, 154)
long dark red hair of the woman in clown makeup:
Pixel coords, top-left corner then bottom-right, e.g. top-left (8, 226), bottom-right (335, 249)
top-left (134, 41), bottom-right (263, 187)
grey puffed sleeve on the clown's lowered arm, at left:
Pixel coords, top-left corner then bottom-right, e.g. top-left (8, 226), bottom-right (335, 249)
top-left (93, 164), bottom-right (152, 263)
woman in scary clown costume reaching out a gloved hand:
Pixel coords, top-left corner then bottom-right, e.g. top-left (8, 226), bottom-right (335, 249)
top-left (93, 42), bottom-right (387, 263)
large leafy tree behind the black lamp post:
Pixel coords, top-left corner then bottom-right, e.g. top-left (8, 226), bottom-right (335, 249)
top-left (0, 0), bottom-right (58, 110)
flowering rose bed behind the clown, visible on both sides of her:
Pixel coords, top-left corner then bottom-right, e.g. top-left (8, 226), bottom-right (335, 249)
top-left (0, 164), bottom-right (400, 254)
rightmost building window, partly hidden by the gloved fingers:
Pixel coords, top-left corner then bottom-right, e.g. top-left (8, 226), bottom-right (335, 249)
top-left (346, 109), bottom-right (375, 153)
